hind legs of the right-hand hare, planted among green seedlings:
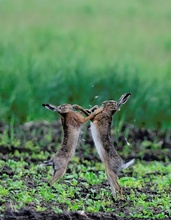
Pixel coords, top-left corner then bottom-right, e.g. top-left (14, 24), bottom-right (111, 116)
top-left (106, 171), bottom-right (124, 200)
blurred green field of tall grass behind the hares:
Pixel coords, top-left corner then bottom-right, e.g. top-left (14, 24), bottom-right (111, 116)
top-left (0, 0), bottom-right (171, 129)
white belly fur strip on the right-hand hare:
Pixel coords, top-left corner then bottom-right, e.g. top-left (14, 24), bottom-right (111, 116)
top-left (91, 122), bottom-right (103, 161)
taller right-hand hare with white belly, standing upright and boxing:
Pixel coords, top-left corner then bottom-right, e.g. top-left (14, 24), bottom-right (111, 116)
top-left (73, 93), bottom-right (134, 199)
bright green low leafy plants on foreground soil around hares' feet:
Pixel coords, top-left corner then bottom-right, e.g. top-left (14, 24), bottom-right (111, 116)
top-left (0, 158), bottom-right (171, 219)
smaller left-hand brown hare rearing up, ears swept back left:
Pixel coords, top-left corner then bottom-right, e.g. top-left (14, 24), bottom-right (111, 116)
top-left (40, 104), bottom-right (101, 185)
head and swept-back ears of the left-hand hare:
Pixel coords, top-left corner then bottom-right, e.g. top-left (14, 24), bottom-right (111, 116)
top-left (42, 104), bottom-right (72, 114)
